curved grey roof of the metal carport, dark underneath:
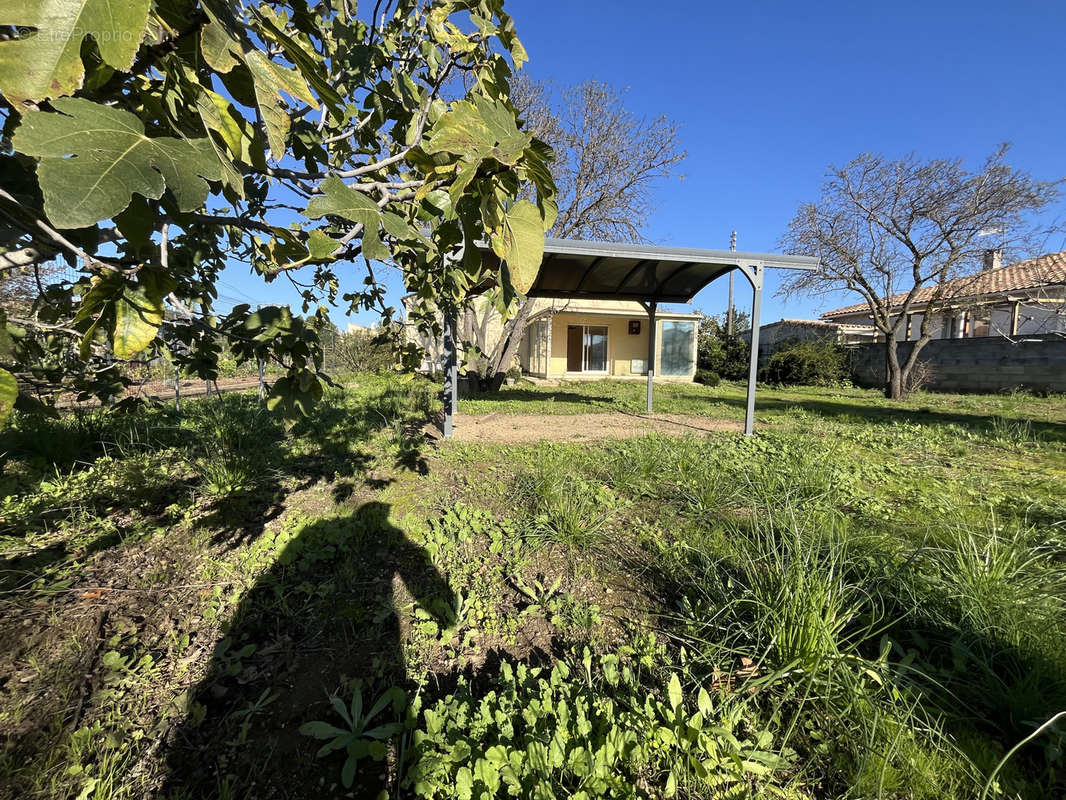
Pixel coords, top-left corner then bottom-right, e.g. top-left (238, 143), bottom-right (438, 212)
top-left (485, 239), bottom-right (818, 303)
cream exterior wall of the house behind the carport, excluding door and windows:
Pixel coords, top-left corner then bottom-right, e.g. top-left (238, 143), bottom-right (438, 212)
top-left (522, 306), bottom-right (698, 381)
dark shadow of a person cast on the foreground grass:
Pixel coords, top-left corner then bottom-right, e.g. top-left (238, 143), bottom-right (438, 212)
top-left (164, 502), bottom-right (455, 798)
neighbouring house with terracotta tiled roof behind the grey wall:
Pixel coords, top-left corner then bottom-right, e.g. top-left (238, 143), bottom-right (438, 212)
top-left (822, 251), bottom-right (1066, 341)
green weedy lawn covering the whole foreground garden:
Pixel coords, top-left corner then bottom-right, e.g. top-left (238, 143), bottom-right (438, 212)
top-left (0, 375), bottom-right (1066, 799)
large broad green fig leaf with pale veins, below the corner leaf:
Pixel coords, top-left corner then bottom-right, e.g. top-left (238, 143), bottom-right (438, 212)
top-left (12, 97), bottom-right (221, 228)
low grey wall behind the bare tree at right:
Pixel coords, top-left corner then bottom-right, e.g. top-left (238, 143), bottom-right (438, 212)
top-left (852, 334), bottom-right (1066, 391)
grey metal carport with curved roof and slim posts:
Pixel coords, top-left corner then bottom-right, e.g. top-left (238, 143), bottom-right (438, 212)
top-left (443, 239), bottom-right (818, 436)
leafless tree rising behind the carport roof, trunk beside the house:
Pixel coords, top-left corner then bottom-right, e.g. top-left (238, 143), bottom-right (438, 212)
top-left (473, 75), bottom-right (685, 388)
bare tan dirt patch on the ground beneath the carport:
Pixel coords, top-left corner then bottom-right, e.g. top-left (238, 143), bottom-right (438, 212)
top-left (443, 412), bottom-right (744, 444)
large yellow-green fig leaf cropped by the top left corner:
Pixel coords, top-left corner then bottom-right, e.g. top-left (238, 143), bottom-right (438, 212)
top-left (0, 0), bottom-right (150, 105)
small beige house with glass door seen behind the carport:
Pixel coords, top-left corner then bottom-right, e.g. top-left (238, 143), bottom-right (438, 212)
top-left (519, 299), bottom-right (699, 381)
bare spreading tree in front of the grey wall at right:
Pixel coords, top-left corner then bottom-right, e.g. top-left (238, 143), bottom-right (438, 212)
top-left (779, 144), bottom-right (1059, 399)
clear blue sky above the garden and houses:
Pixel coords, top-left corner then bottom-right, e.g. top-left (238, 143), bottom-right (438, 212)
top-left (220, 0), bottom-right (1066, 326)
